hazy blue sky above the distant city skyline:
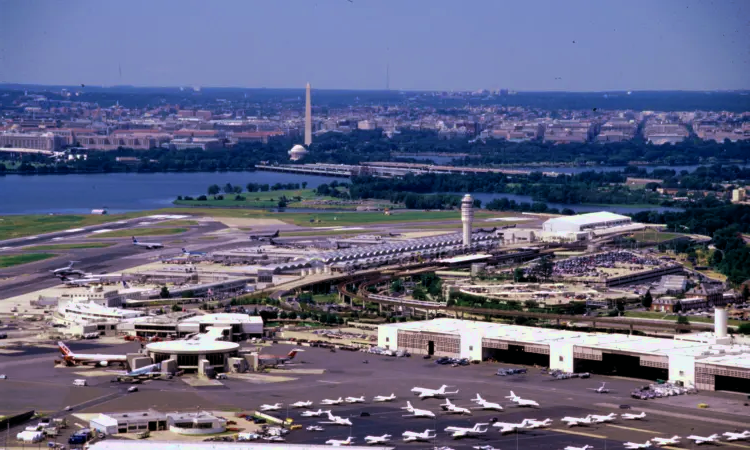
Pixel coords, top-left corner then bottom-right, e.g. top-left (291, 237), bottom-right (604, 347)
top-left (0, 0), bottom-right (750, 91)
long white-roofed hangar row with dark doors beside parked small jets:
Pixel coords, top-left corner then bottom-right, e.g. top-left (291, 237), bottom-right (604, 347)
top-left (378, 316), bottom-right (750, 393)
